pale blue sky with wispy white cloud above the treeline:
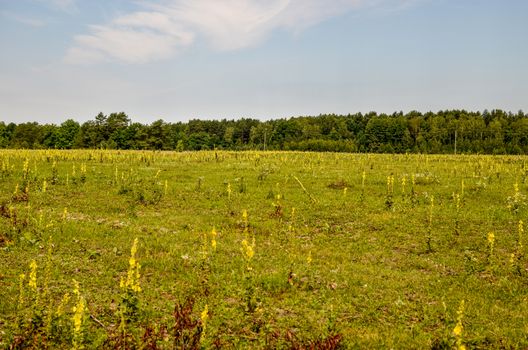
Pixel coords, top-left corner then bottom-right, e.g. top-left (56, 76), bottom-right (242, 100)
top-left (0, 0), bottom-right (528, 124)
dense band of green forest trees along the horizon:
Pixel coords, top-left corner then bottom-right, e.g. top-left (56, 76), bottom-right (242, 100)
top-left (0, 110), bottom-right (528, 154)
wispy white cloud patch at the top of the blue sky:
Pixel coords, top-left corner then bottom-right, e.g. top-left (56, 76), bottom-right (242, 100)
top-left (66, 0), bottom-right (402, 64)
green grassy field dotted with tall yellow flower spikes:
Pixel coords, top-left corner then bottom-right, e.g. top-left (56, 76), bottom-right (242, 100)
top-left (0, 150), bottom-right (528, 349)
